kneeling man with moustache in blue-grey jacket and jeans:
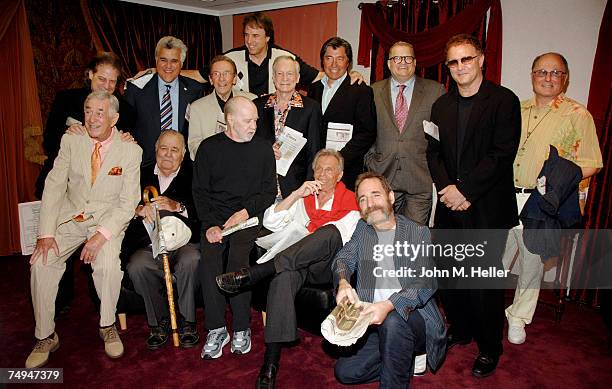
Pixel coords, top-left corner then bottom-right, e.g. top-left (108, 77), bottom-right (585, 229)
top-left (332, 172), bottom-right (446, 388)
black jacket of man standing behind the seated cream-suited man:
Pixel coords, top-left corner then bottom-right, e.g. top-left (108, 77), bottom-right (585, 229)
top-left (36, 87), bottom-right (132, 198)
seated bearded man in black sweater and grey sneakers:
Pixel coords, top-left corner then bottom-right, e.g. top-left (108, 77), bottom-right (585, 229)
top-left (192, 96), bottom-right (276, 359)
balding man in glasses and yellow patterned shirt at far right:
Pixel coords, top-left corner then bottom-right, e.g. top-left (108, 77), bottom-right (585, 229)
top-left (504, 53), bottom-right (603, 344)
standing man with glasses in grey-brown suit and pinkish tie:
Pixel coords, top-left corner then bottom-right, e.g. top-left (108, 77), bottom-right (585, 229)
top-left (366, 41), bottom-right (446, 225)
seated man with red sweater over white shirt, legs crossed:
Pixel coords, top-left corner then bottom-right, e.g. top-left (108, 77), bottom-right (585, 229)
top-left (217, 149), bottom-right (359, 388)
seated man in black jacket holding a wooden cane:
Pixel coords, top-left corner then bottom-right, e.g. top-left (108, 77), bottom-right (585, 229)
top-left (122, 130), bottom-right (200, 350)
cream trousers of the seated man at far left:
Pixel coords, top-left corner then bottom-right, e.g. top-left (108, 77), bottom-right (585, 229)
top-left (30, 219), bottom-right (123, 339)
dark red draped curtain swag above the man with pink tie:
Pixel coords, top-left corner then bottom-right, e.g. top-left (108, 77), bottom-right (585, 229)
top-left (357, 0), bottom-right (502, 84)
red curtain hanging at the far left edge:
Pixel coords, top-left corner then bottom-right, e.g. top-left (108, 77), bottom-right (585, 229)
top-left (0, 0), bottom-right (42, 256)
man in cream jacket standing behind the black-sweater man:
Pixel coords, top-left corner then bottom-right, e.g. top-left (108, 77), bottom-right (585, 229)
top-left (187, 55), bottom-right (257, 161)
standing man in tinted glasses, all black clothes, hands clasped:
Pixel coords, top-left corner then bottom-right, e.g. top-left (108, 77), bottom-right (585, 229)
top-left (427, 34), bottom-right (521, 377)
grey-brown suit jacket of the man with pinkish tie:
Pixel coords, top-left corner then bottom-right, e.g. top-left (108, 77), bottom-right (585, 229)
top-left (366, 77), bottom-right (446, 194)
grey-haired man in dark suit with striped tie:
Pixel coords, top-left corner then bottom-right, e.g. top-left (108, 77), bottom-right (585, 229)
top-left (125, 36), bottom-right (203, 164)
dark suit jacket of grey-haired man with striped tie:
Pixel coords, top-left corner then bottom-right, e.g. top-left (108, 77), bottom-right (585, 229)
top-left (125, 74), bottom-right (204, 165)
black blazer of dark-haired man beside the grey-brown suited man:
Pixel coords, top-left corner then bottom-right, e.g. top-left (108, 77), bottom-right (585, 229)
top-left (308, 76), bottom-right (376, 190)
